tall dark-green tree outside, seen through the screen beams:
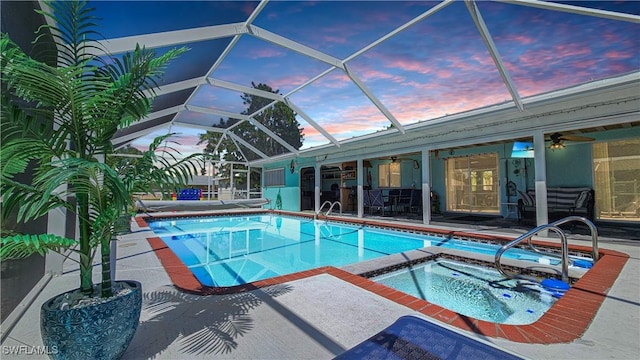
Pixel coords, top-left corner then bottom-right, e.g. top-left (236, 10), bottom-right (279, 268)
top-left (198, 82), bottom-right (304, 188)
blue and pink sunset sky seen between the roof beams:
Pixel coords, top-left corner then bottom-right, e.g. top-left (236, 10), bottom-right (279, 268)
top-left (95, 1), bottom-right (640, 157)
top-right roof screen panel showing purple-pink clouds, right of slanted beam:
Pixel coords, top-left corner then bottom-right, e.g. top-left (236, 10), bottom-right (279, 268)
top-left (478, 2), bottom-right (640, 96)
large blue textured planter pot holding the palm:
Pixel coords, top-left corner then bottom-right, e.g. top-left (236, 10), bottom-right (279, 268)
top-left (40, 280), bottom-right (142, 360)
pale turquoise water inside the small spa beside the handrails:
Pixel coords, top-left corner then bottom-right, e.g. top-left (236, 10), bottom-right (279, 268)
top-left (372, 259), bottom-right (556, 325)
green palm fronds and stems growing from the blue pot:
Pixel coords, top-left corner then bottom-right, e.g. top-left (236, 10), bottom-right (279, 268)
top-left (0, 1), bottom-right (199, 296)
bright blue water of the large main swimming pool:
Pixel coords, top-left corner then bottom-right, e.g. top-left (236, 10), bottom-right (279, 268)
top-left (149, 214), bottom-right (580, 286)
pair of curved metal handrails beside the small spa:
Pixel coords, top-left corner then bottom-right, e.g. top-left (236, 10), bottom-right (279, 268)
top-left (495, 216), bottom-right (598, 284)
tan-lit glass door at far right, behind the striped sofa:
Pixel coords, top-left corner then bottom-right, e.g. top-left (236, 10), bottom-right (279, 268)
top-left (593, 139), bottom-right (640, 221)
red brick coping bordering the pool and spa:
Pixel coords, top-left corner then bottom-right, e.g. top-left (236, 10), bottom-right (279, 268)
top-left (135, 211), bottom-right (629, 344)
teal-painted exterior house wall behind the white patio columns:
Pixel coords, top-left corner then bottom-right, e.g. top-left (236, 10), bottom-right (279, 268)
top-left (263, 127), bottom-right (640, 216)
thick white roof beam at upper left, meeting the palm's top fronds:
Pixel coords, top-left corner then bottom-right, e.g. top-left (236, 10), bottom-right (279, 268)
top-left (100, 23), bottom-right (247, 54)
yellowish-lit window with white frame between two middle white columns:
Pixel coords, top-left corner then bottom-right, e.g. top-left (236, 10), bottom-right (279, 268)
top-left (445, 153), bottom-right (500, 214)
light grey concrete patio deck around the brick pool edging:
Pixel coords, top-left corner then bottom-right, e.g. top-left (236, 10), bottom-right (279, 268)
top-left (2, 211), bottom-right (640, 359)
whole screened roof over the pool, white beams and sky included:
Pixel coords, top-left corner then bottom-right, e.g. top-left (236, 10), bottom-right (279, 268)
top-left (46, 1), bottom-right (640, 162)
